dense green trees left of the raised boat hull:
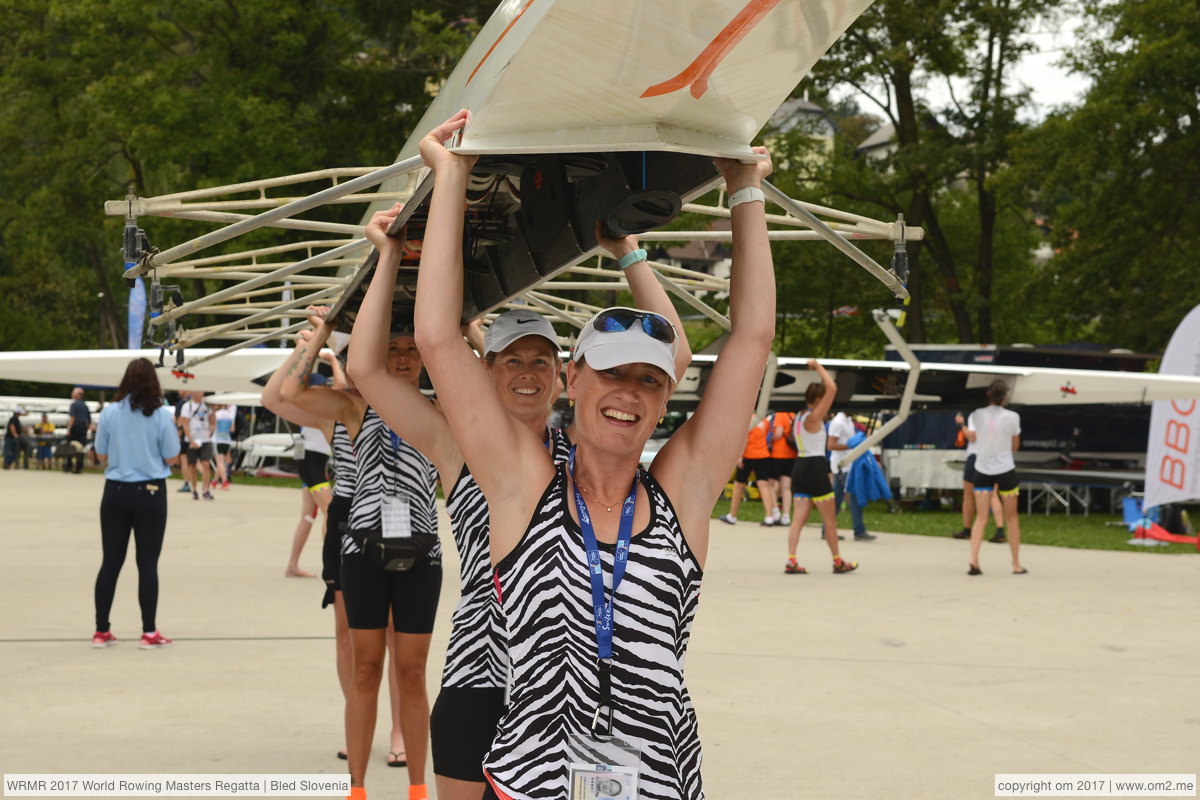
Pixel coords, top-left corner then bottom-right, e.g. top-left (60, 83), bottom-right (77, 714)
top-left (0, 0), bottom-right (478, 349)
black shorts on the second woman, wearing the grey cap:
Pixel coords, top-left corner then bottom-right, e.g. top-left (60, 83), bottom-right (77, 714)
top-left (430, 686), bottom-right (504, 783)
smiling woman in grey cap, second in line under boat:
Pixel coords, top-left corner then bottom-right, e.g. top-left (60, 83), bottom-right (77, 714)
top-left (349, 184), bottom-right (691, 800)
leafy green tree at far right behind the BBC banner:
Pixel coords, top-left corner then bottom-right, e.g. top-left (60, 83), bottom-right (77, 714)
top-left (1007, 0), bottom-right (1200, 350)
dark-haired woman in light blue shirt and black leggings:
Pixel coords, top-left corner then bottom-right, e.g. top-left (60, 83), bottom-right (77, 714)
top-left (91, 359), bottom-right (179, 650)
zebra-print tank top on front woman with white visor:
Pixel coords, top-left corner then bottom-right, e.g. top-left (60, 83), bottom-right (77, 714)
top-left (484, 464), bottom-right (704, 800)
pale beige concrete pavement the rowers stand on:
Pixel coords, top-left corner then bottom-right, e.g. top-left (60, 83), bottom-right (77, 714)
top-left (0, 471), bottom-right (1200, 800)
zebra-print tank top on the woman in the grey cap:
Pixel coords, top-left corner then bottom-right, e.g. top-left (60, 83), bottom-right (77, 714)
top-left (442, 428), bottom-right (571, 688)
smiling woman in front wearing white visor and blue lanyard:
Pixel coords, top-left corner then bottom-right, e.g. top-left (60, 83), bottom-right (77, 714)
top-left (415, 112), bottom-right (775, 800)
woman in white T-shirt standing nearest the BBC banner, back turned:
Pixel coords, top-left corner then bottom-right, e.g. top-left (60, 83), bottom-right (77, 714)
top-left (965, 380), bottom-right (1027, 575)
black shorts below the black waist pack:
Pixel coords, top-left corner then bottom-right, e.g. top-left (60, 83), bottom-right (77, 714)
top-left (342, 553), bottom-right (442, 633)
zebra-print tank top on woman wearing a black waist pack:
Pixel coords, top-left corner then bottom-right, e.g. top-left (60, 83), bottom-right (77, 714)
top-left (342, 408), bottom-right (442, 559)
